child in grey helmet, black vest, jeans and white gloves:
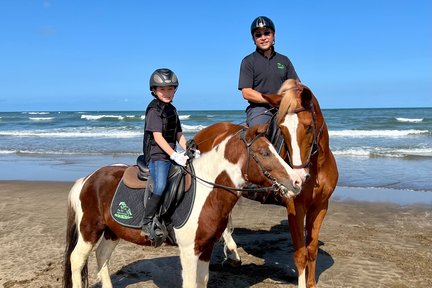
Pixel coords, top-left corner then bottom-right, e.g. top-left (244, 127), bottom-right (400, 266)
top-left (142, 68), bottom-right (189, 236)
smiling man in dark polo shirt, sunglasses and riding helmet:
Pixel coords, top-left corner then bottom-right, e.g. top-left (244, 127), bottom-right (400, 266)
top-left (238, 16), bottom-right (299, 126)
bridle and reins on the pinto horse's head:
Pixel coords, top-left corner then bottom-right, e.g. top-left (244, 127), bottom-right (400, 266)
top-left (183, 128), bottom-right (289, 196)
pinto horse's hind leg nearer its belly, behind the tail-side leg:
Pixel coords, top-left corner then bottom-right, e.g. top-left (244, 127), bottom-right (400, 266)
top-left (96, 237), bottom-right (120, 288)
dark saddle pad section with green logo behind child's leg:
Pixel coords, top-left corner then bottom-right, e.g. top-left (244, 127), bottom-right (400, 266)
top-left (111, 180), bottom-right (145, 228)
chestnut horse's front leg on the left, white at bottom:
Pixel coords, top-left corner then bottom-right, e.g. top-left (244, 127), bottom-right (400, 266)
top-left (288, 201), bottom-right (307, 288)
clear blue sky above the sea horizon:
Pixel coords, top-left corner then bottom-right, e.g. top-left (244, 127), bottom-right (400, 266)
top-left (0, 0), bottom-right (432, 111)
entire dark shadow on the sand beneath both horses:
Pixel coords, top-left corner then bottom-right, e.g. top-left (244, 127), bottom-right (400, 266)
top-left (92, 220), bottom-right (334, 288)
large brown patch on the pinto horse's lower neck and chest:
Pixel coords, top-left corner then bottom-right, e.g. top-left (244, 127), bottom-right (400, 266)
top-left (194, 171), bottom-right (239, 262)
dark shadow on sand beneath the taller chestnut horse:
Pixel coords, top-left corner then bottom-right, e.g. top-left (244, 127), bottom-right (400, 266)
top-left (209, 220), bottom-right (334, 288)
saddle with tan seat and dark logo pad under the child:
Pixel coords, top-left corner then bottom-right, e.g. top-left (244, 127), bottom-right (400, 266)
top-left (111, 157), bottom-right (195, 247)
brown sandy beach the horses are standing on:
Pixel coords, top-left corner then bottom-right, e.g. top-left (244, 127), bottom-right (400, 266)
top-left (0, 181), bottom-right (432, 288)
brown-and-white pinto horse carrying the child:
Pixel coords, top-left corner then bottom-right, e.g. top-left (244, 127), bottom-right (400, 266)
top-left (63, 123), bottom-right (301, 287)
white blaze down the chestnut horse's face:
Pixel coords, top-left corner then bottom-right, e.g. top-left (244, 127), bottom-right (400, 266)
top-left (281, 113), bottom-right (309, 182)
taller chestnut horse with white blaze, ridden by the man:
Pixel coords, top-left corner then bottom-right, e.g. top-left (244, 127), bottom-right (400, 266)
top-left (194, 80), bottom-right (338, 288)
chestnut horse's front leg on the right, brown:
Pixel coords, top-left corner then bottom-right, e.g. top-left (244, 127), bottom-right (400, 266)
top-left (306, 201), bottom-right (328, 288)
